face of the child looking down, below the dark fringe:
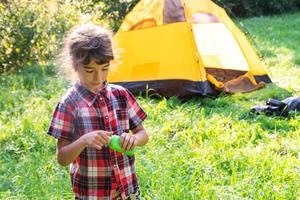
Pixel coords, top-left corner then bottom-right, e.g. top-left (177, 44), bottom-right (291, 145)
top-left (77, 60), bottom-right (109, 93)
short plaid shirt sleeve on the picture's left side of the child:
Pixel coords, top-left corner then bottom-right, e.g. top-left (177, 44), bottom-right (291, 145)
top-left (48, 103), bottom-right (74, 142)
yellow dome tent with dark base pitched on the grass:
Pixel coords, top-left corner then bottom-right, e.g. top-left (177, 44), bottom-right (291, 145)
top-left (108, 0), bottom-right (271, 97)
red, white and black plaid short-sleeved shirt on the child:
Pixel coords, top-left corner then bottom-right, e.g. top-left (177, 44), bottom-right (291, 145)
top-left (48, 83), bottom-right (146, 199)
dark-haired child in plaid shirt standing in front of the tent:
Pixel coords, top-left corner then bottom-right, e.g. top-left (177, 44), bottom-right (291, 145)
top-left (48, 24), bottom-right (148, 199)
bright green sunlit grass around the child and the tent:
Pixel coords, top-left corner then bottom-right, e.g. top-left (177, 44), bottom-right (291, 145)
top-left (0, 12), bottom-right (300, 199)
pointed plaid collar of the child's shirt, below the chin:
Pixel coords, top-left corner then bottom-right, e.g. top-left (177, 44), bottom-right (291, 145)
top-left (75, 81), bottom-right (112, 106)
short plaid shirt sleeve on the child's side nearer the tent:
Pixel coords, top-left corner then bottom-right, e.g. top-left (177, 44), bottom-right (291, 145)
top-left (127, 91), bottom-right (147, 130)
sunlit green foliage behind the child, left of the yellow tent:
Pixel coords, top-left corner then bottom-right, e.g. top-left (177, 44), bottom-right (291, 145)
top-left (0, 0), bottom-right (137, 73)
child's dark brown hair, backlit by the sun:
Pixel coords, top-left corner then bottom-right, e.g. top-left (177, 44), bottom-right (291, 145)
top-left (58, 23), bottom-right (114, 80)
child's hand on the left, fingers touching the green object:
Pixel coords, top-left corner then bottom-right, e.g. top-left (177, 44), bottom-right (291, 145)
top-left (81, 130), bottom-right (113, 150)
